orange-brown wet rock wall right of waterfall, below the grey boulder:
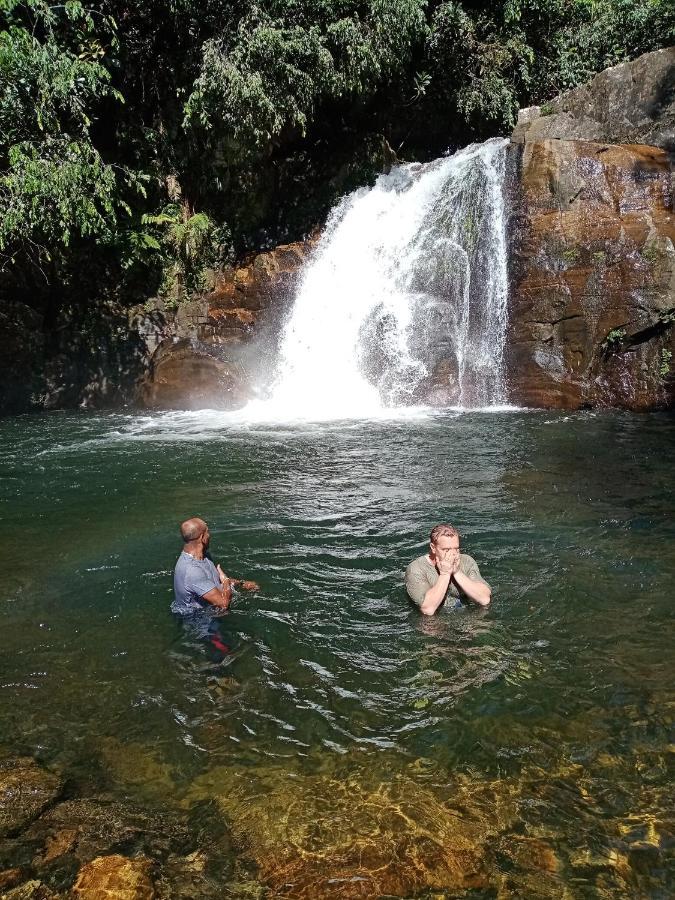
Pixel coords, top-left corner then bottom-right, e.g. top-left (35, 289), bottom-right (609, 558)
top-left (508, 140), bottom-right (675, 409)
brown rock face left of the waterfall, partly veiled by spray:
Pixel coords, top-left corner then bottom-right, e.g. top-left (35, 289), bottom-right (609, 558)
top-left (139, 239), bottom-right (314, 409)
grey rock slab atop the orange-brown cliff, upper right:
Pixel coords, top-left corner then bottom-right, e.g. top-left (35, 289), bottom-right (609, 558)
top-left (513, 47), bottom-right (675, 152)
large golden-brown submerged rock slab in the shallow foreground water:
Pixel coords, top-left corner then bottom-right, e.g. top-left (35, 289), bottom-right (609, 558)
top-left (185, 763), bottom-right (496, 900)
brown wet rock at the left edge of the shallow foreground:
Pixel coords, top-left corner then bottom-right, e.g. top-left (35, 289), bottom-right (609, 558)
top-left (0, 757), bottom-right (61, 837)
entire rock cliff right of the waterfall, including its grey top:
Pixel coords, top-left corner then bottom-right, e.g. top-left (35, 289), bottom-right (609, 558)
top-left (507, 47), bottom-right (675, 409)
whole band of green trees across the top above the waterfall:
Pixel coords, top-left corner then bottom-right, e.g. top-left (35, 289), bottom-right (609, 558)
top-left (0, 0), bottom-right (675, 305)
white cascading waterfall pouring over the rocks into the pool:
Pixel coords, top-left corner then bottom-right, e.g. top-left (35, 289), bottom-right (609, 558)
top-left (252, 139), bottom-right (507, 419)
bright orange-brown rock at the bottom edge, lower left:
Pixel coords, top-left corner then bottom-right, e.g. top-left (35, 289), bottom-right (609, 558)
top-left (72, 855), bottom-right (155, 900)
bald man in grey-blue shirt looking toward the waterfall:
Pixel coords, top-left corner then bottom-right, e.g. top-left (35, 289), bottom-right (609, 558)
top-left (171, 519), bottom-right (234, 615)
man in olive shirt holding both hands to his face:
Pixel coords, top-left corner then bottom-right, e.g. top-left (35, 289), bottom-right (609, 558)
top-left (405, 525), bottom-right (492, 616)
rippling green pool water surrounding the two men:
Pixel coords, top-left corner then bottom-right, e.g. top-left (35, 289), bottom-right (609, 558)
top-left (0, 412), bottom-right (675, 897)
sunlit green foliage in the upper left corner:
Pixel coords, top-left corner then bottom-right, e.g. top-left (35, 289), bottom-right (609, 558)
top-left (0, 0), bottom-right (135, 268)
